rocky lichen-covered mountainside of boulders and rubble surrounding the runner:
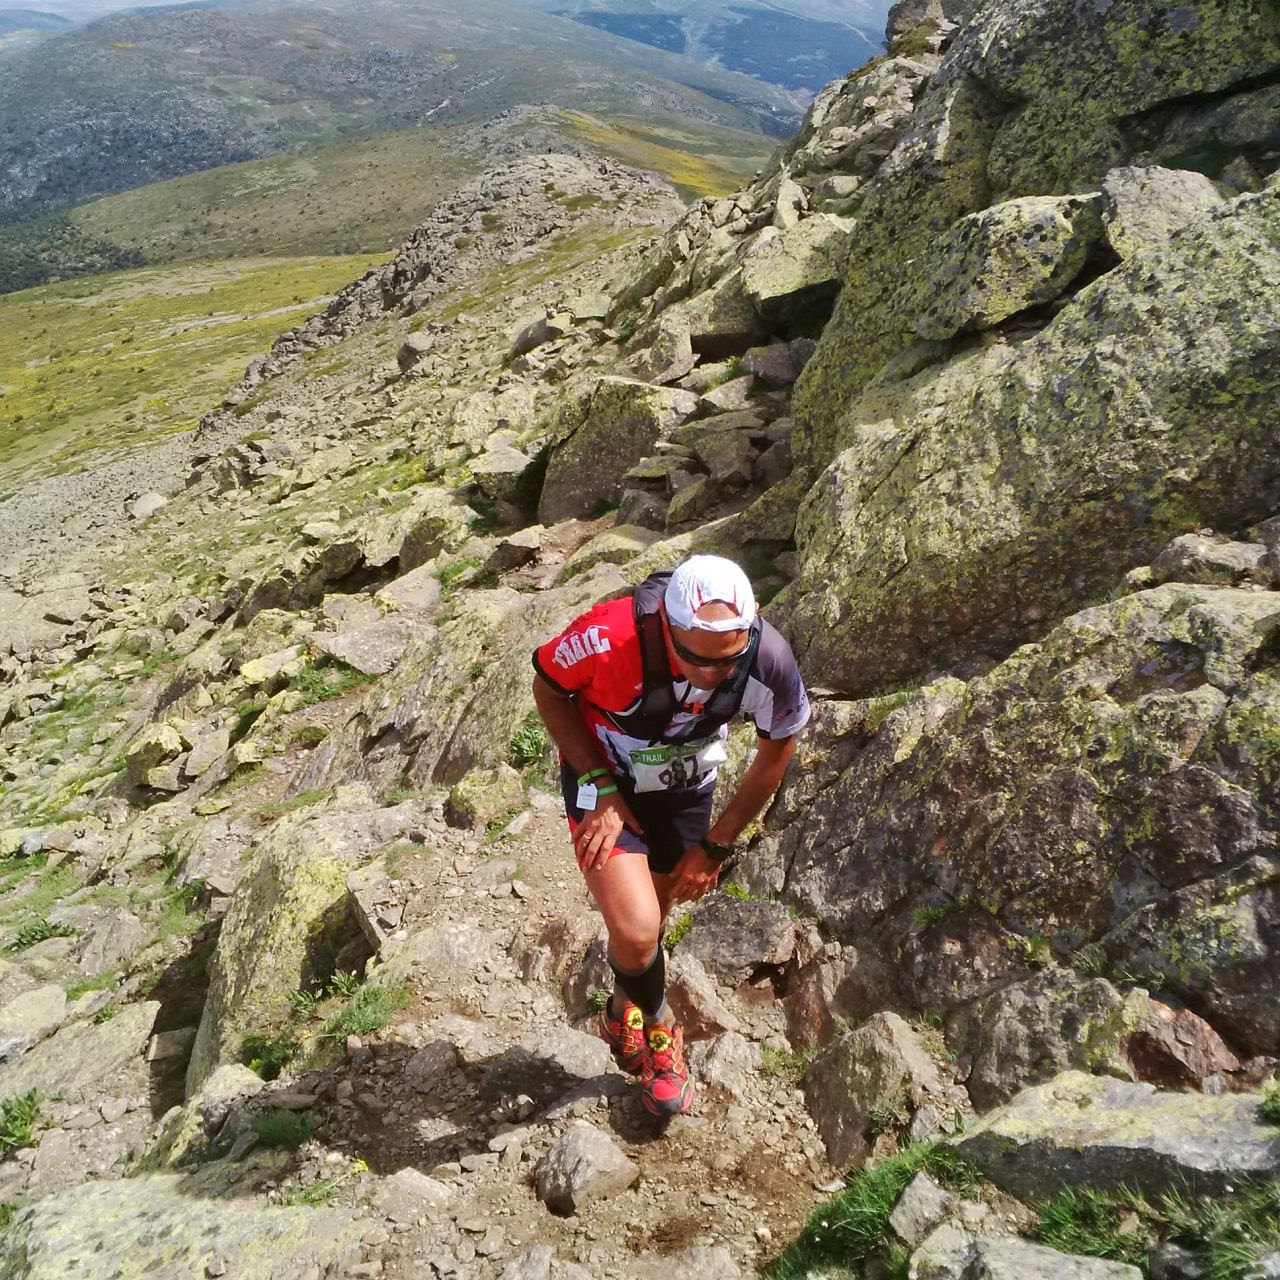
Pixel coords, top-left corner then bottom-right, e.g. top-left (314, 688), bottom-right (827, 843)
top-left (0, 0), bottom-right (1280, 1280)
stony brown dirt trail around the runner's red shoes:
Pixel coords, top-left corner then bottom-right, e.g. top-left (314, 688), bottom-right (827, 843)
top-left (291, 797), bottom-right (832, 1280)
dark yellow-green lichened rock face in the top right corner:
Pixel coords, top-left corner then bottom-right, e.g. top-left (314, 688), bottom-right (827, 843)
top-left (796, 0), bottom-right (1280, 463)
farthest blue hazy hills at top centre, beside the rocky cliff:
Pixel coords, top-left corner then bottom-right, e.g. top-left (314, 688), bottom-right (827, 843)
top-left (512, 0), bottom-right (888, 93)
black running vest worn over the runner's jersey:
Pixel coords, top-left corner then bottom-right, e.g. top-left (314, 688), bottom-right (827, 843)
top-left (600, 570), bottom-right (760, 742)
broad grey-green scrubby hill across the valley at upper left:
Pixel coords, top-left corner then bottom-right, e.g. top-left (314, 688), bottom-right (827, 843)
top-left (0, 0), bottom-right (803, 224)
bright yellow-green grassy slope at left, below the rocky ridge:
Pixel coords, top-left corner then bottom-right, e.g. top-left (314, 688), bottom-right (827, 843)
top-left (0, 255), bottom-right (381, 495)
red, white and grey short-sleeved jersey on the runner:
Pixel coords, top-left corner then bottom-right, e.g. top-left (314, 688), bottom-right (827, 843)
top-left (534, 595), bottom-right (809, 791)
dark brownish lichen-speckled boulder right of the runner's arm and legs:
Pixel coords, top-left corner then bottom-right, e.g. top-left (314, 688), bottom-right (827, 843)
top-left (771, 584), bottom-right (1280, 1059)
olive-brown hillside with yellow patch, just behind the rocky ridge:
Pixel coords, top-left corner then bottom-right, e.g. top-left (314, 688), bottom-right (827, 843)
top-left (0, 109), bottom-right (769, 293)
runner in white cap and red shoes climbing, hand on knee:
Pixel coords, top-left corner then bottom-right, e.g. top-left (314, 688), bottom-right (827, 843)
top-left (534, 556), bottom-right (809, 1115)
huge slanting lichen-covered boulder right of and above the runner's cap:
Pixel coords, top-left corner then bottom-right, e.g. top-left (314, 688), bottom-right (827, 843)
top-left (778, 188), bottom-right (1280, 694)
